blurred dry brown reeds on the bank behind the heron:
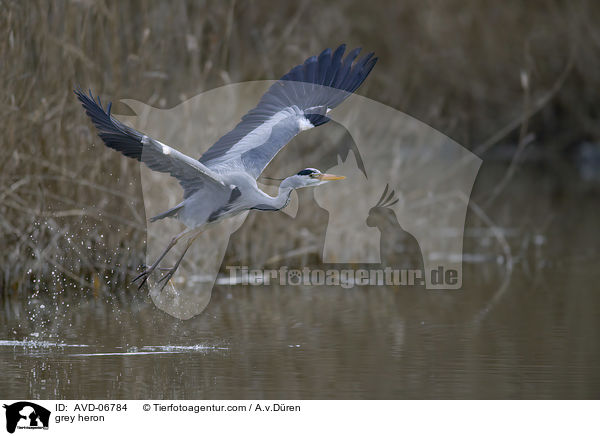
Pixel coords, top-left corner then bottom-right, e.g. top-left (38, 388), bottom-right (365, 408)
top-left (0, 0), bottom-right (600, 298)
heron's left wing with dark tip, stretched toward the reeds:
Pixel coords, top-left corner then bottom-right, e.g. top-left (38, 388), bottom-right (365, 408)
top-left (75, 90), bottom-right (225, 198)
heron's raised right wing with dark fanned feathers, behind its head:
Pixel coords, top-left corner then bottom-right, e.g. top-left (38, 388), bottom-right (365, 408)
top-left (200, 45), bottom-right (377, 178)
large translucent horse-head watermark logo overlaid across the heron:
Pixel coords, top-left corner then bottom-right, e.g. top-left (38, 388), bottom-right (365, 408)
top-left (119, 81), bottom-right (481, 319)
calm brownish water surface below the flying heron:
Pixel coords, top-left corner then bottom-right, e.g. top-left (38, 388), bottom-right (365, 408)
top-left (0, 161), bottom-right (600, 399)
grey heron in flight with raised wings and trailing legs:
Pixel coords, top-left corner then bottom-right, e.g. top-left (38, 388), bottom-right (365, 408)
top-left (75, 44), bottom-right (377, 290)
